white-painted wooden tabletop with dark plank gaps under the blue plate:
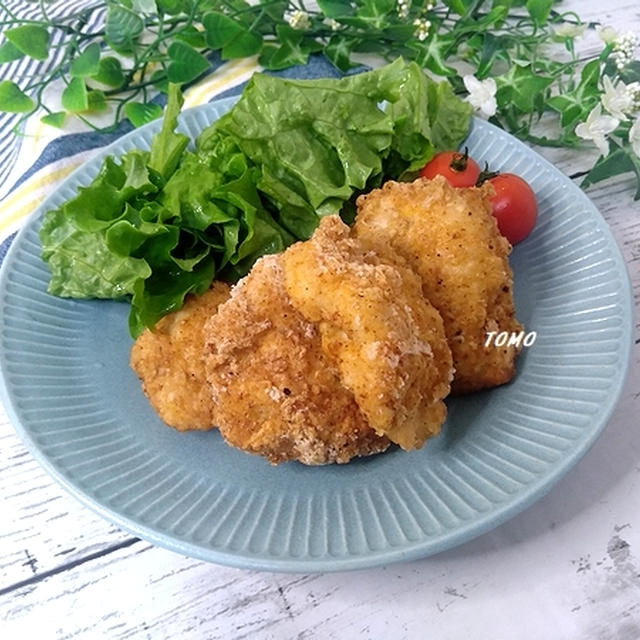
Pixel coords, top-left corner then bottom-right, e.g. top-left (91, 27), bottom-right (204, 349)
top-left (0, 0), bottom-right (640, 640)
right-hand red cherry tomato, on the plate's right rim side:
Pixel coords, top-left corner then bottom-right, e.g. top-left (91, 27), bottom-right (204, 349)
top-left (488, 173), bottom-right (538, 244)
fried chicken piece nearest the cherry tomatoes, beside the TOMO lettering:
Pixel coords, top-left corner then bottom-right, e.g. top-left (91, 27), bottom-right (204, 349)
top-left (354, 176), bottom-right (522, 393)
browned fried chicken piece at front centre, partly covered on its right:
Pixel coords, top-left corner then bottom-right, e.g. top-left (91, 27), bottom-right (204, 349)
top-left (205, 255), bottom-right (389, 465)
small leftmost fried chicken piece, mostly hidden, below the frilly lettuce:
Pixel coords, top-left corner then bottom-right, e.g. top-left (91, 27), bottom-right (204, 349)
top-left (130, 282), bottom-right (229, 431)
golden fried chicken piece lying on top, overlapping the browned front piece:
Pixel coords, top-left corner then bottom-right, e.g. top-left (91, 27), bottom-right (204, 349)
top-left (282, 216), bottom-right (453, 449)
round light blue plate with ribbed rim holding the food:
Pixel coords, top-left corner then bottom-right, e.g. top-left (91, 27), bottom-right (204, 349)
top-left (0, 100), bottom-right (632, 572)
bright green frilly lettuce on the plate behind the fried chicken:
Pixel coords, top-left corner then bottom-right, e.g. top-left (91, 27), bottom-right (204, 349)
top-left (40, 59), bottom-right (471, 336)
